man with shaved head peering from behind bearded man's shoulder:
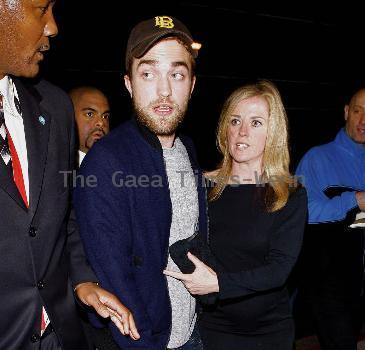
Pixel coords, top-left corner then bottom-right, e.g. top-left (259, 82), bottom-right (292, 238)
top-left (70, 86), bottom-right (110, 165)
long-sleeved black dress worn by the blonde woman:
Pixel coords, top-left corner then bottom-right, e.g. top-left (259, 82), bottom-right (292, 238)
top-left (199, 184), bottom-right (307, 350)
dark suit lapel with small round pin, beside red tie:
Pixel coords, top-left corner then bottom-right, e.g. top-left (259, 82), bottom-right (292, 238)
top-left (14, 79), bottom-right (51, 215)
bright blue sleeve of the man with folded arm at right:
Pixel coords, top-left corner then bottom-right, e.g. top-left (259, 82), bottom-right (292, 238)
top-left (296, 148), bottom-right (357, 224)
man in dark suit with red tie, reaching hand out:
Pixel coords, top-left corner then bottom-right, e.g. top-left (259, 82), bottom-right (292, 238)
top-left (0, 0), bottom-right (135, 350)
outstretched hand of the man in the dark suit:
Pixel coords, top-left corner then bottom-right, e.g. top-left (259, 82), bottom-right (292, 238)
top-left (75, 282), bottom-right (140, 340)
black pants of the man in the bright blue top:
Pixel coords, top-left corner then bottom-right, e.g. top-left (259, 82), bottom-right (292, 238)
top-left (298, 221), bottom-right (364, 350)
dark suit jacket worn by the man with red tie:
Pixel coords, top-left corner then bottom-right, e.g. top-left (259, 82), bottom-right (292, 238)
top-left (0, 78), bottom-right (96, 350)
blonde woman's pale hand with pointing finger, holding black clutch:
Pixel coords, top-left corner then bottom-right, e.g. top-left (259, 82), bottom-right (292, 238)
top-left (163, 252), bottom-right (219, 295)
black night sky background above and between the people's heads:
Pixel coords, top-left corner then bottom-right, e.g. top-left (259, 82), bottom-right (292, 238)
top-left (43, 0), bottom-right (365, 169)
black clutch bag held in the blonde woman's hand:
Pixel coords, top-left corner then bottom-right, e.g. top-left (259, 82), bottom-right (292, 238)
top-left (169, 231), bottom-right (220, 305)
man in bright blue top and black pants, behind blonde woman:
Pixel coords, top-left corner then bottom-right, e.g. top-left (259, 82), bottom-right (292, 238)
top-left (297, 89), bottom-right (365, 350)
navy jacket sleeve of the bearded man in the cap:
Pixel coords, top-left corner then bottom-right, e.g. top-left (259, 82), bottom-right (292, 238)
top-left (74, 144), bottom-right (158, 350)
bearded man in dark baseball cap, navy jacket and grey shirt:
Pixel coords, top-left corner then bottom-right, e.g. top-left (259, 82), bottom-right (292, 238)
top-left (75, 16), bottom-right (207, 350)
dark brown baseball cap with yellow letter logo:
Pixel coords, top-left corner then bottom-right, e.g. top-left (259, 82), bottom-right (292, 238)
top-left (125, 16), bottom-right (198, 70)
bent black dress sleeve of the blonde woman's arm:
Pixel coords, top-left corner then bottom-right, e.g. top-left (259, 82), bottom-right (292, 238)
top-left (218, 188), bottom-right (307, 299)
